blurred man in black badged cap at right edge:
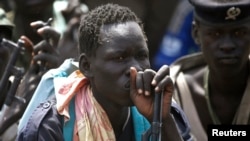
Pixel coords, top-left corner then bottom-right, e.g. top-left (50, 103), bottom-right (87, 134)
top-left (170, 0), bottom-right (250, 141)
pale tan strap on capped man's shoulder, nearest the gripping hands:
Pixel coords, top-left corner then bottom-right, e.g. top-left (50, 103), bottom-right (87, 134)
top-left (176, 72), bottom-right (207, 141)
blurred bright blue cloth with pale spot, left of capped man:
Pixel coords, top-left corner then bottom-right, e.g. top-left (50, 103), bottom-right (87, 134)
top-left (153, 0), bottom-right (200, 69)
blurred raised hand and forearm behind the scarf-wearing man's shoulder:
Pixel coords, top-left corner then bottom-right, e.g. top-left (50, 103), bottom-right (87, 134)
top-left (16, 21), bottom-right (60, 102)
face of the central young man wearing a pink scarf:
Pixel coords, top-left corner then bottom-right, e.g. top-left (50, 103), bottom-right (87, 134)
top-left (90, 22), bottom-right (150, 105)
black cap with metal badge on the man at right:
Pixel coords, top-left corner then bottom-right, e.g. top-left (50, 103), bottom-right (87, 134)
top-left (189, 0), bottom-right (250, 25)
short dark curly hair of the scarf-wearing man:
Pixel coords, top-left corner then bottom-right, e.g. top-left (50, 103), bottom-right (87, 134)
top-left (78, 3), bottom-right (143, 56)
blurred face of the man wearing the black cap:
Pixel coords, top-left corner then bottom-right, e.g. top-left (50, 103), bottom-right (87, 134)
top-left (194, 20), bottom-right (250, 74)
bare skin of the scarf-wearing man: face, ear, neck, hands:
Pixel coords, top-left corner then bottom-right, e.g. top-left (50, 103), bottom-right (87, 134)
top-left (79, 22), bottom-right (181, 140)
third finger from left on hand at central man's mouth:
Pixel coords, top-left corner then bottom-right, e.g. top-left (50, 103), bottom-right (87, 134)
top-left (143, 69), bottom-right (155, 96)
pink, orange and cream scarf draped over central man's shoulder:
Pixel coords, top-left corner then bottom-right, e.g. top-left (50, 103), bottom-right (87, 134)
top-left (56, 70), bottom-right (115, 141)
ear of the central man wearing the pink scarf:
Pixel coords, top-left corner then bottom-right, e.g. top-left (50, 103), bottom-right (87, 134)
top-left (79, 53), bottom-right (93, 78)
